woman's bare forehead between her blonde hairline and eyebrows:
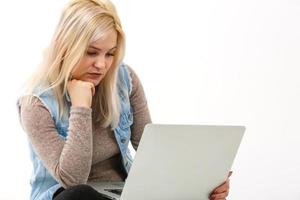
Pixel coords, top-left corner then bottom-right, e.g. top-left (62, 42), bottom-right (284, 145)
top-left (89, 30), bottom-right (118, 49)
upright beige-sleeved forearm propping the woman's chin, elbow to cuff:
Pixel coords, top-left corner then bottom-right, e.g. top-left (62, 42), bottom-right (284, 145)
top-left (55, 107), bottom-right (93, 186)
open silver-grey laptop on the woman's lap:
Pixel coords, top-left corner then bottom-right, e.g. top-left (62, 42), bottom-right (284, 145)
top-left (89, 124), bottom-right (245, 200)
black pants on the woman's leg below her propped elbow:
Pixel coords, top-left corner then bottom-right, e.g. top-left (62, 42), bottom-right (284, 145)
top-left (53, 185), bottom-right (107, 200)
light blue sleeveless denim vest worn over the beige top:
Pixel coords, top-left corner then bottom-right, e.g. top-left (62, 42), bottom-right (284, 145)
top-left (17, 64), bottom-right (133, 200)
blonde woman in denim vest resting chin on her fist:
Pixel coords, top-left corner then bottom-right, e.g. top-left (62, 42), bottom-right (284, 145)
top-left (18, 0), bottom-right (229, 200)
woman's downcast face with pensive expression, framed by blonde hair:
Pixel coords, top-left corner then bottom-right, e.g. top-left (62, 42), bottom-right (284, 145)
top-left (72, 30), bottom-right (117, 86)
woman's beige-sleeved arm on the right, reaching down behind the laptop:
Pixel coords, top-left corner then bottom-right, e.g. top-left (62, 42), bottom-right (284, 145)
top-left (128, 67), bottom-right (151, 150)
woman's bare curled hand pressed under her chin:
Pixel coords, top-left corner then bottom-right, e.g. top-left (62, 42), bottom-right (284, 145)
top-left (67, 79), bottom-right (95, 108)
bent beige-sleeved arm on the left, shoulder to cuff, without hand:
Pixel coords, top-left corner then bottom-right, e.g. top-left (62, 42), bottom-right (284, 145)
top-left (20, 98), bottom-right (92, 188)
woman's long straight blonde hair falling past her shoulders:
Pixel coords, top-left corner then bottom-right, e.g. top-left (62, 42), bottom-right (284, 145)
top-left (28, 0), bottom-right (125, 129)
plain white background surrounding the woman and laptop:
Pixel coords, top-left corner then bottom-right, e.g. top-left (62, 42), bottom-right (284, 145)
top-left (0, 0), bottom-right (300, 200)
